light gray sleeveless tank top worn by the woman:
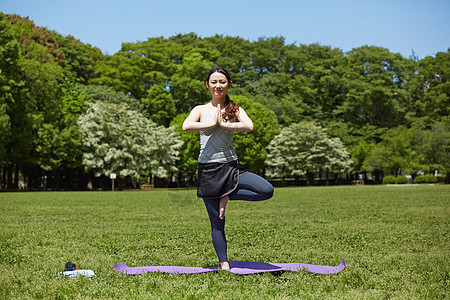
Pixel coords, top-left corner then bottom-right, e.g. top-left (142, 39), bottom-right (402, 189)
top-left (198, 103), bottom-right (238, 163)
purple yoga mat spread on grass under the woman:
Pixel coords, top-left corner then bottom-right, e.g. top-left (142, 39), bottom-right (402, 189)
top-left (114, 260), bottom-right (345, 275)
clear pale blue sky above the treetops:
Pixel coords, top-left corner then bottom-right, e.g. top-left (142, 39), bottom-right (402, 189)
top-left (0, 0), bottom-right (450, 58)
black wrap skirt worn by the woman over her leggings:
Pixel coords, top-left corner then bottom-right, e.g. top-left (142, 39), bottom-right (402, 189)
top-left (197, 160), bottom-right (247, 199)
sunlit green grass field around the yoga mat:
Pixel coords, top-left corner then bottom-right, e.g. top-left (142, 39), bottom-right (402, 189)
top-left (0, 185), bottom-right (450, 299)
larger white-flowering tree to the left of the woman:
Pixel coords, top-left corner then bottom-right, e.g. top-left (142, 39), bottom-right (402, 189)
top-left (78, 101), bottom-right (183, 178)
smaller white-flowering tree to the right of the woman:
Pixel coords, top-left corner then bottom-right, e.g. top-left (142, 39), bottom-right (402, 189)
top-left (266, 122), bottom-right (352, 182)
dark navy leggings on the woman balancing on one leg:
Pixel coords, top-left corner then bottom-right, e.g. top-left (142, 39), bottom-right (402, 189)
top-left (203, 172), bottom-right (273, 262)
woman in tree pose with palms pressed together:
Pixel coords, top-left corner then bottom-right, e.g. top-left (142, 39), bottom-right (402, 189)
top-left (183, 67), bottom-right (273, 270)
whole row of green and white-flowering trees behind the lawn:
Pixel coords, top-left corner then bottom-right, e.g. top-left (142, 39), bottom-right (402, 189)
top-left (0, 13), bottom-right (450, 188)
